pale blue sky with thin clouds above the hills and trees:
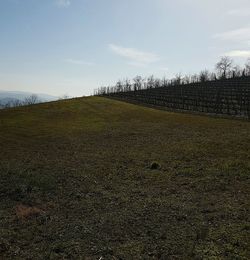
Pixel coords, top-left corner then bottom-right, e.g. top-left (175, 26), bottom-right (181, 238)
top-left (0, 0), bottom-right (250, 96)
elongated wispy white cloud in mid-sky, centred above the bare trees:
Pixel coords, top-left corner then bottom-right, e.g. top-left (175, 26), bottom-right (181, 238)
top-left (109, 44), bottom-right (159, 67)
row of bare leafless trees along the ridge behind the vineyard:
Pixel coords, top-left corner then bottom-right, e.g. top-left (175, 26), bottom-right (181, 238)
top-left (94, 56), bottom-right (250, 95)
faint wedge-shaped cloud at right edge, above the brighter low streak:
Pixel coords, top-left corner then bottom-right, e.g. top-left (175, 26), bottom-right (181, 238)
top-left (213, 27), bottom-right (250, 41)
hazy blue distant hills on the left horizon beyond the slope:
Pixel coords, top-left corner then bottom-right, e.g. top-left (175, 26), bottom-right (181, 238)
top-left (0, 90), bottom-right (58, 106)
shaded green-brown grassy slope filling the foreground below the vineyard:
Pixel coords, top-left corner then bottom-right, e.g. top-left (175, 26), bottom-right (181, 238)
top-left (0, 97), bottom-right (250, 259)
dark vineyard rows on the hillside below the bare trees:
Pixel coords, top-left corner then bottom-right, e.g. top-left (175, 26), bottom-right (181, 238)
top-left (104, 76), bottom-right (250, 119)
